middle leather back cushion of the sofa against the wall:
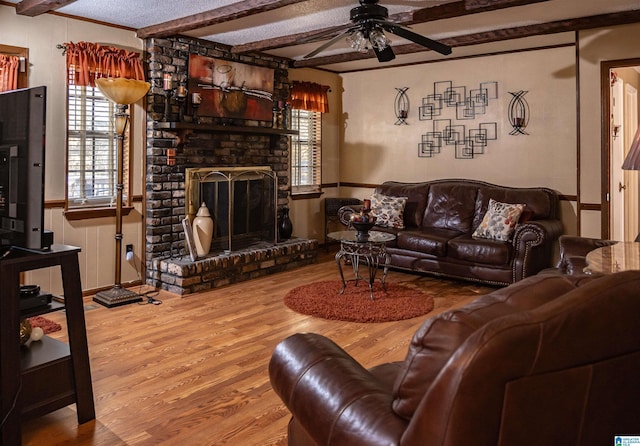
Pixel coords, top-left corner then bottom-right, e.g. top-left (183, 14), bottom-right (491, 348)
top-left (422, 182), bottom-right (477, 232)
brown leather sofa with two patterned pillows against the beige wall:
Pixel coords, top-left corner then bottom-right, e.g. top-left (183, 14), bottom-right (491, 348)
top-left (339, 179), bottom-right (562, 285)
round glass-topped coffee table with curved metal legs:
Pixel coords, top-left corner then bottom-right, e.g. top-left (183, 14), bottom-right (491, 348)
top-left (327, 231), bottom-right (396, 300)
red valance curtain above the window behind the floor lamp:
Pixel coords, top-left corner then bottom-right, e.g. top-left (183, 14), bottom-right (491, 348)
top-left (64, 42), bottom-right (144, 87)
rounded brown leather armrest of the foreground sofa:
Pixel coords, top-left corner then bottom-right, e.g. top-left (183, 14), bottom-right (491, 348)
top-left (269, 333), bottom-right (407, 446)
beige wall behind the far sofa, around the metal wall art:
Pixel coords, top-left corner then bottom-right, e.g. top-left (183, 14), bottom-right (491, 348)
top-left (340, 24), bottom-right (640, 237)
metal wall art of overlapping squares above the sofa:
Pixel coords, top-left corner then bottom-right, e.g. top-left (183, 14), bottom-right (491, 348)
top-left (418, 81), bottom-right (498, 159)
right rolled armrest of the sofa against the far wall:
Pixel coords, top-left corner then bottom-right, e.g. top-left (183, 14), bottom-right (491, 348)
top-left (512, 220), bottom-right (562, 282)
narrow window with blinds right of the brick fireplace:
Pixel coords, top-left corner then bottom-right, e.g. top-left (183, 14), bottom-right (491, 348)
top-left (291, 109), bottom-right (322, 194)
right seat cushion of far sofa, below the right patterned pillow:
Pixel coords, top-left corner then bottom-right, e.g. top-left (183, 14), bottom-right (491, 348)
top-left (447, 234), bottom-right (512, 265)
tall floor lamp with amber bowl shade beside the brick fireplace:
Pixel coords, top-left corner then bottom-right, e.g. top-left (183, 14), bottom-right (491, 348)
top-left (93, 77), bottom-right (150, 307)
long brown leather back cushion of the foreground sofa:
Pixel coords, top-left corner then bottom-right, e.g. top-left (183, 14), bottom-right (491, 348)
top-left (392, 275), bottom-right (592, 419)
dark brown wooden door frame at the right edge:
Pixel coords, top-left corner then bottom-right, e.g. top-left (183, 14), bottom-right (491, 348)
top-left (600, 58), bottom-right (640, 239)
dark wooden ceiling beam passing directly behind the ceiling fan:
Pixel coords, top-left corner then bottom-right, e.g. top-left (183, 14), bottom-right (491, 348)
top-left (231, 0), bottom-right (549, 54)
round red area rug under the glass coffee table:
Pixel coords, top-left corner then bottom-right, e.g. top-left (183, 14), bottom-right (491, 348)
top-left (284, 280), bottom-right (433, 322)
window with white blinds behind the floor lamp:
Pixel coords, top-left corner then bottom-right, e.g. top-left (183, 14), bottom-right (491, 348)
top-left (67, 73), bottom-right (128, 209)
